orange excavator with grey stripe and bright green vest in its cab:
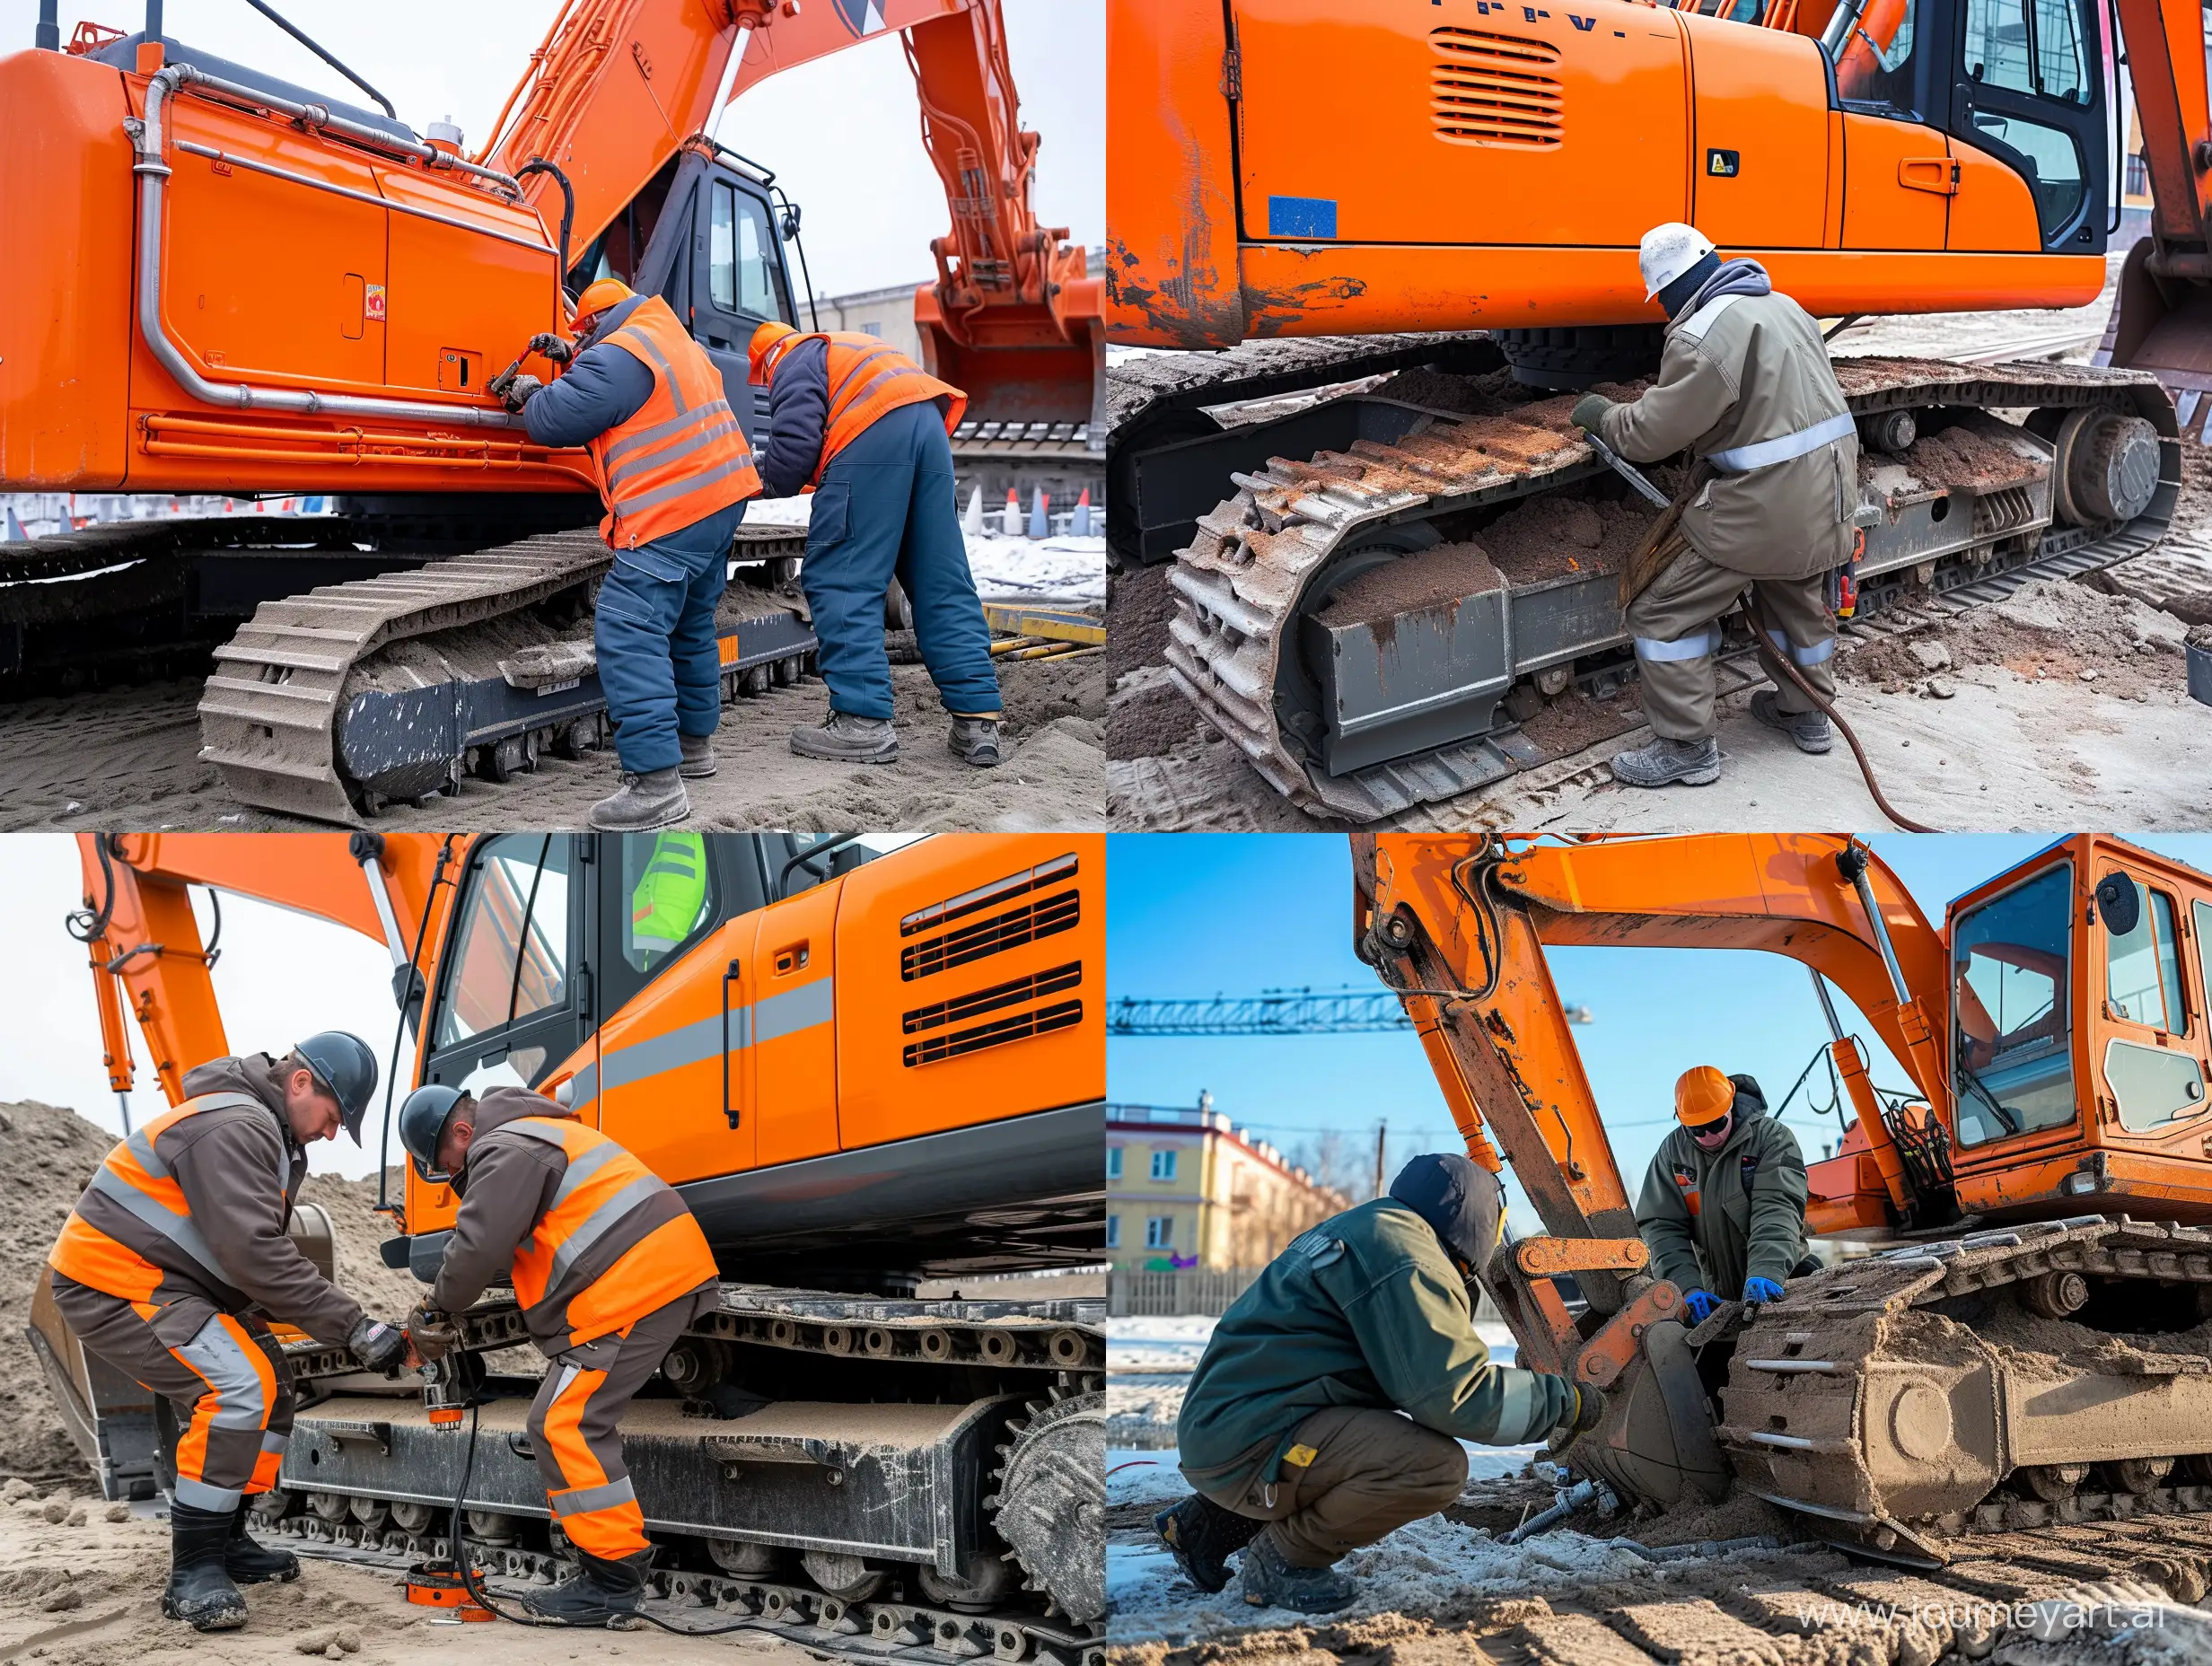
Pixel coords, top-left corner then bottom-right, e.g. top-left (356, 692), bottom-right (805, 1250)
top-left (33, 832), bottom-right (1106, 1666)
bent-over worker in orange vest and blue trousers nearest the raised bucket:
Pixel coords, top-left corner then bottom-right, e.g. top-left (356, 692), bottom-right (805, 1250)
top-left (752, 323), bottom-right (1002, 767)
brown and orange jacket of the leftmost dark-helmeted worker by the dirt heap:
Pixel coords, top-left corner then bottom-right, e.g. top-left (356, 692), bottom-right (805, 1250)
top-left (51, 1053), bottom-right (363, 1343)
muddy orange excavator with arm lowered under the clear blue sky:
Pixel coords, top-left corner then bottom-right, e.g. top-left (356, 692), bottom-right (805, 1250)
top-left (1352, 834), bottom-right (2212, 1566)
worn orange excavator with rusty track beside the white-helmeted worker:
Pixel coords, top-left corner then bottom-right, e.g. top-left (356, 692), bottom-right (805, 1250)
top-left (1106, 0), bottom-right (2212, 820)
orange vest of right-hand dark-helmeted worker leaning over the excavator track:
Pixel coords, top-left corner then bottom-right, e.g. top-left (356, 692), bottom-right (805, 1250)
top-left (487, 1118), bottom-right (715, 1347)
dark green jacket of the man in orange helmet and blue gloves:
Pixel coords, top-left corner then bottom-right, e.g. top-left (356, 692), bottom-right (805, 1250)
top-left (1637, 1093), bottom-right (1807, 1301)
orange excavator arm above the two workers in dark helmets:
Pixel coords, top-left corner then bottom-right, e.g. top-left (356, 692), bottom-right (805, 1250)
top-left (71, 834), bottom-right (462, 1119)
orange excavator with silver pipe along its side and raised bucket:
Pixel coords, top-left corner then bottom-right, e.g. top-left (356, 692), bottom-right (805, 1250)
top-left (0, 0), bottom-right (1104, 820)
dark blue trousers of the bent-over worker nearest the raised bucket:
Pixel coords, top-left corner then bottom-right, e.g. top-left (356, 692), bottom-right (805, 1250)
top-left (799, 403), bottom-right (1000, 719)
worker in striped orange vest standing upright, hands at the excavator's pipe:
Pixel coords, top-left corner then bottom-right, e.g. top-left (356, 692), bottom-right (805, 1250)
top-left (506, 279), bottom-right (761, 832)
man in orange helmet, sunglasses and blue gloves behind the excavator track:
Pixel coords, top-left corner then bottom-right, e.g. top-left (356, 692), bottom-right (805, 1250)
top-left (1637, 1065), bottom-right (1821, 1365)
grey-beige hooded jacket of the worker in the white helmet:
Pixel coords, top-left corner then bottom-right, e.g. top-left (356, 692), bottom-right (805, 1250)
top-left (1597, 261), bottom-right (1858, 577)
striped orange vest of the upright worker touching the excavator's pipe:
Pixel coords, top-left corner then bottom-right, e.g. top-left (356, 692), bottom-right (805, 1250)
top-left (584, 294), bottom-right (761, 548)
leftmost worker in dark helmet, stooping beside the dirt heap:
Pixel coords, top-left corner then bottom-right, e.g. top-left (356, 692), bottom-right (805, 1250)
top-left (47, 1031), bottom-right (407, 1631)
